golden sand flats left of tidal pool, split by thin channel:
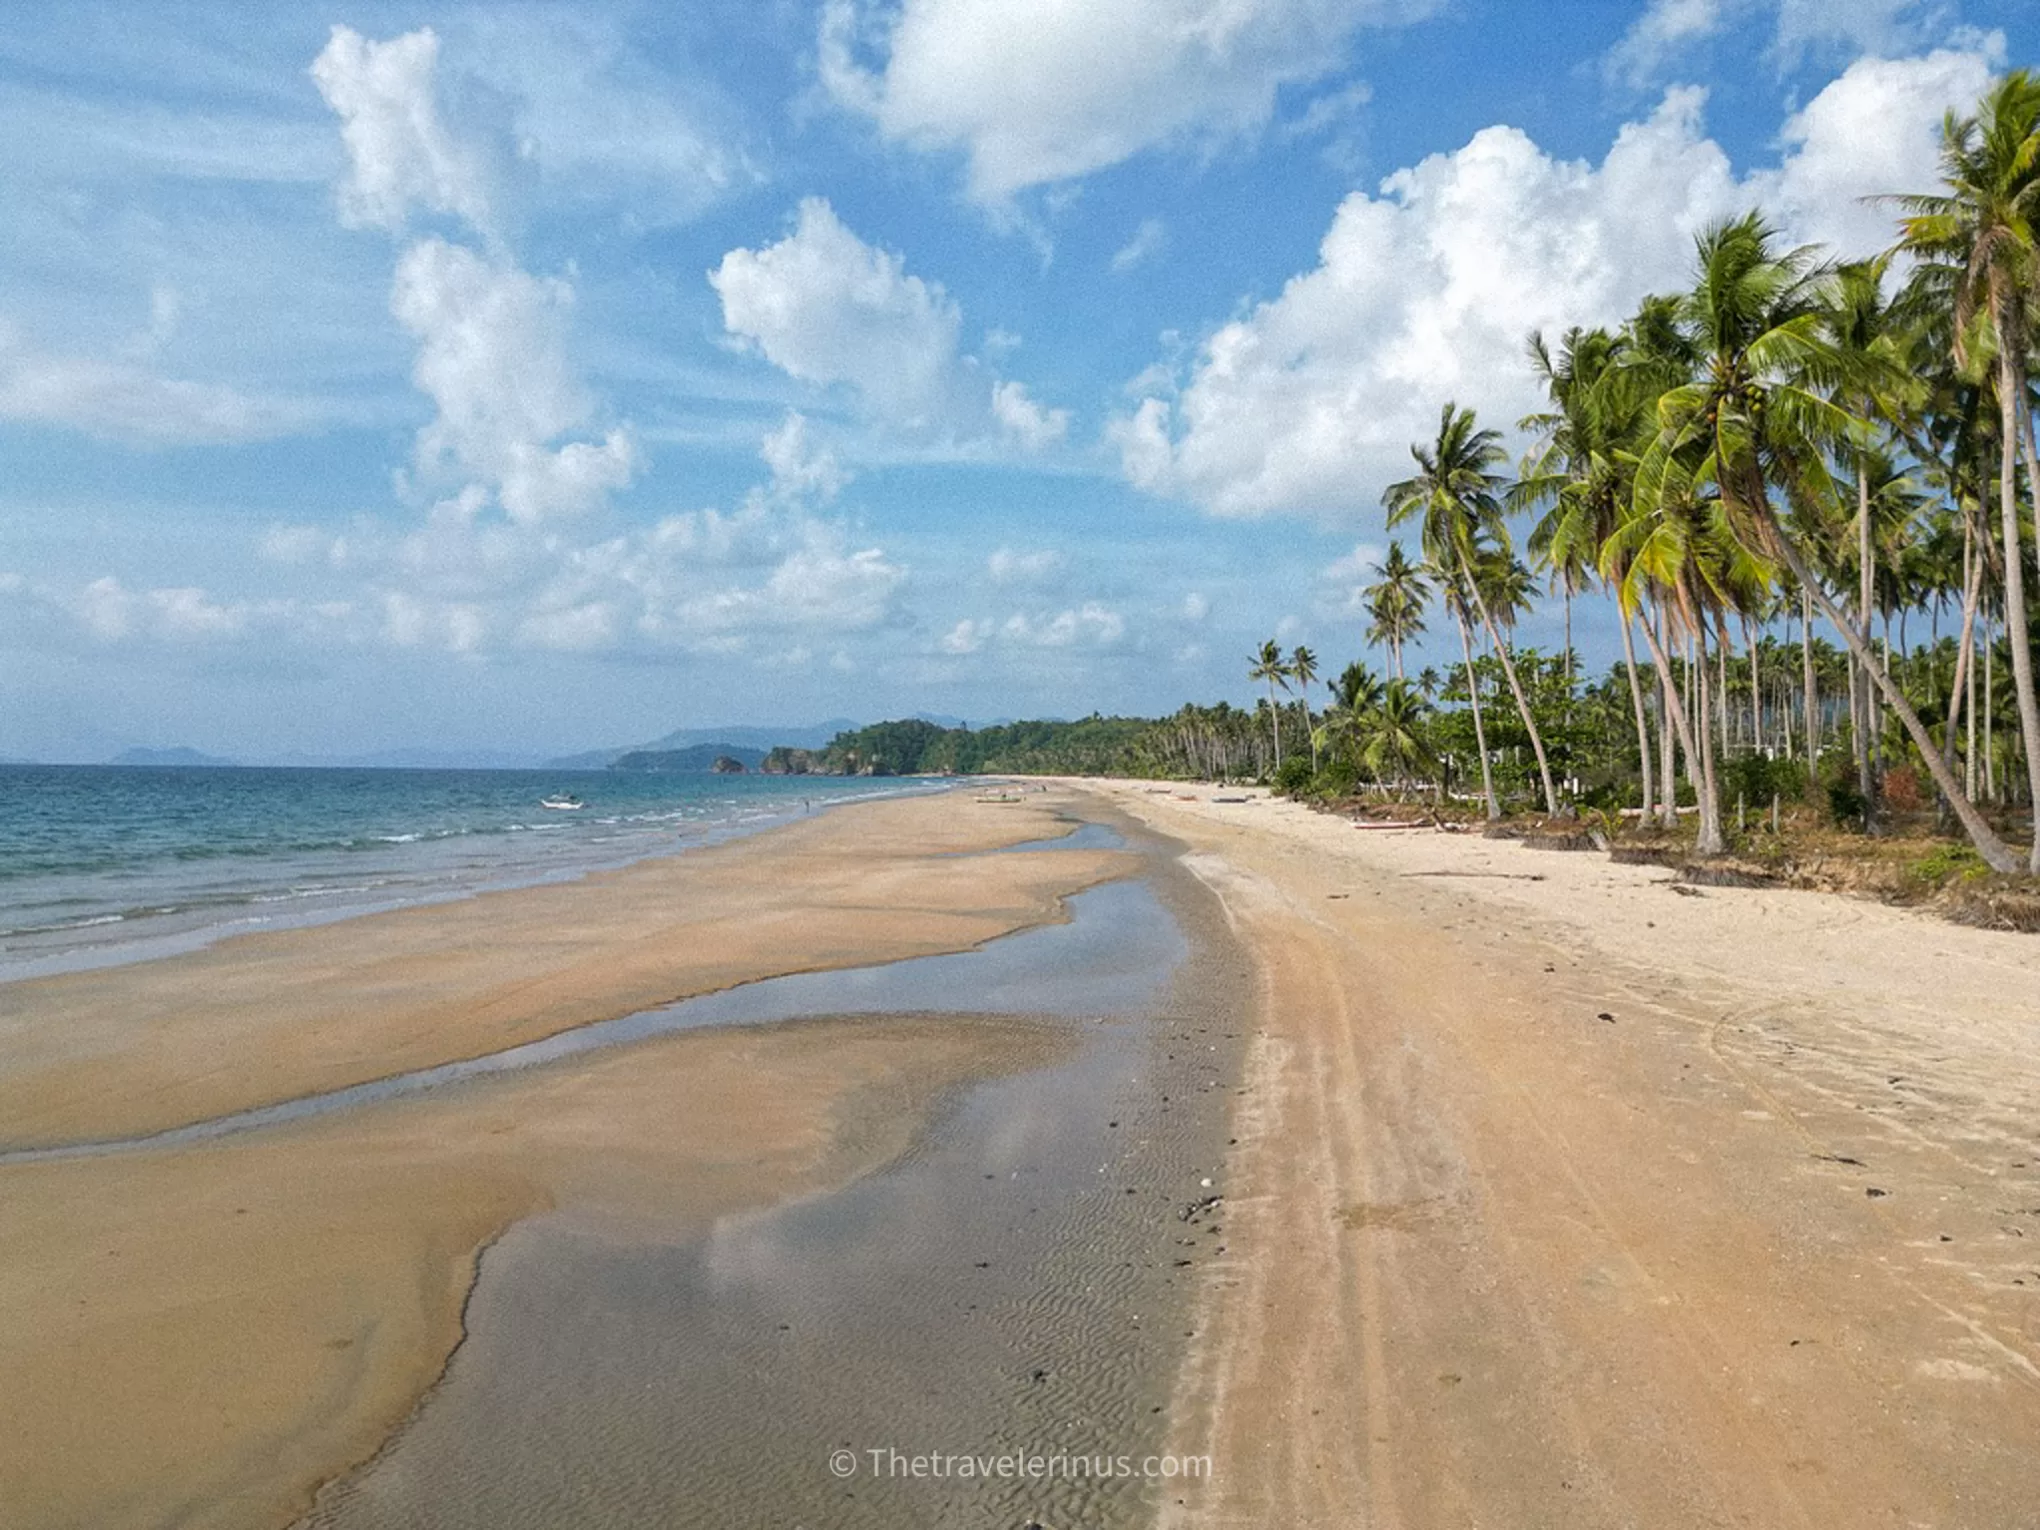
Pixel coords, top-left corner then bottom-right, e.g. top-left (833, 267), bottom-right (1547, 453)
top-left (0, 796), bottom-right (1130, 1530)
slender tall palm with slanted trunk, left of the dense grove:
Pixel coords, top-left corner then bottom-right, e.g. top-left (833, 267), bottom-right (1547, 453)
top-left (1381, 404), bottom-right (1559, 816)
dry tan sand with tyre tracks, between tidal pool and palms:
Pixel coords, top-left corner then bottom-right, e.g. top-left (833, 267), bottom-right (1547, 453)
top-left (1068, 783), bottom-right (2040, 1530)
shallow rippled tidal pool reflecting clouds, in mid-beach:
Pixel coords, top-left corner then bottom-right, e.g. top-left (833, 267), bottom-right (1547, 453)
top-left (291, 816), bottom-right (1244, 1530)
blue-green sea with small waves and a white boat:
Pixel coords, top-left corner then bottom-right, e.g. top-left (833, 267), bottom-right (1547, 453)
top-left (0, 765), bottom-right (932, 981)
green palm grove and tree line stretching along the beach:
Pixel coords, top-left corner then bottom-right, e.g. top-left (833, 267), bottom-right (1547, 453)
top-left (783, 69), bottom-right (2040, 873)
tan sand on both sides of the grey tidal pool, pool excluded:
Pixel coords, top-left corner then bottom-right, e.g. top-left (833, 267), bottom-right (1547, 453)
top-left (0, 783), bottom-right (2040, 1530)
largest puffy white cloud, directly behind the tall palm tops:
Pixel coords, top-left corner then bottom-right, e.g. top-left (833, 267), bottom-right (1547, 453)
top-left (1110, 53), bottom-right (1989, 516)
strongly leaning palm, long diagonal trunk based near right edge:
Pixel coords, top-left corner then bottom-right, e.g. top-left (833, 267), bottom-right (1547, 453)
top-left (1634, 212), bottom-right (2015, 871)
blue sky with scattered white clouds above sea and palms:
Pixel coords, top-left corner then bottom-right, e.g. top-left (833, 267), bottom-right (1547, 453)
top-left (0, 0), bottom-right (2034, 759)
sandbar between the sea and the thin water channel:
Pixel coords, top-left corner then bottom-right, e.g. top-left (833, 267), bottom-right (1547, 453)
top-left (0, 794), bottom-right (1126, 1149)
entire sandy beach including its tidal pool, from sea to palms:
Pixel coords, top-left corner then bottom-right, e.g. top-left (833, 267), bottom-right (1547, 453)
top-left (0, 781), bottom-right (2040, 1530)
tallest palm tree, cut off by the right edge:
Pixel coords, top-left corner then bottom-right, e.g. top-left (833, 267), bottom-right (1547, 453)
top-left (1897, 69), bottom-right (2040, 875)
